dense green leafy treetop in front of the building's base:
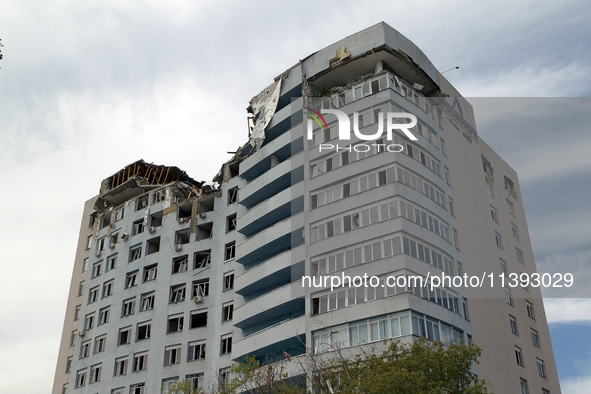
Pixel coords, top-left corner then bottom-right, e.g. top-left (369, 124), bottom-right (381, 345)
top-left (313, 338), bottom-right (488, 394)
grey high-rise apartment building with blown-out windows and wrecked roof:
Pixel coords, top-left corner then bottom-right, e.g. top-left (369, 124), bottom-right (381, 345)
top-left (53, 23), bottom-right (560, 394)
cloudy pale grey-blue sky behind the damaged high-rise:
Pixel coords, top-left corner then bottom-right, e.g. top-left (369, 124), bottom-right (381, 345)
top-left (0, 0), bottom-right (591, 394)
